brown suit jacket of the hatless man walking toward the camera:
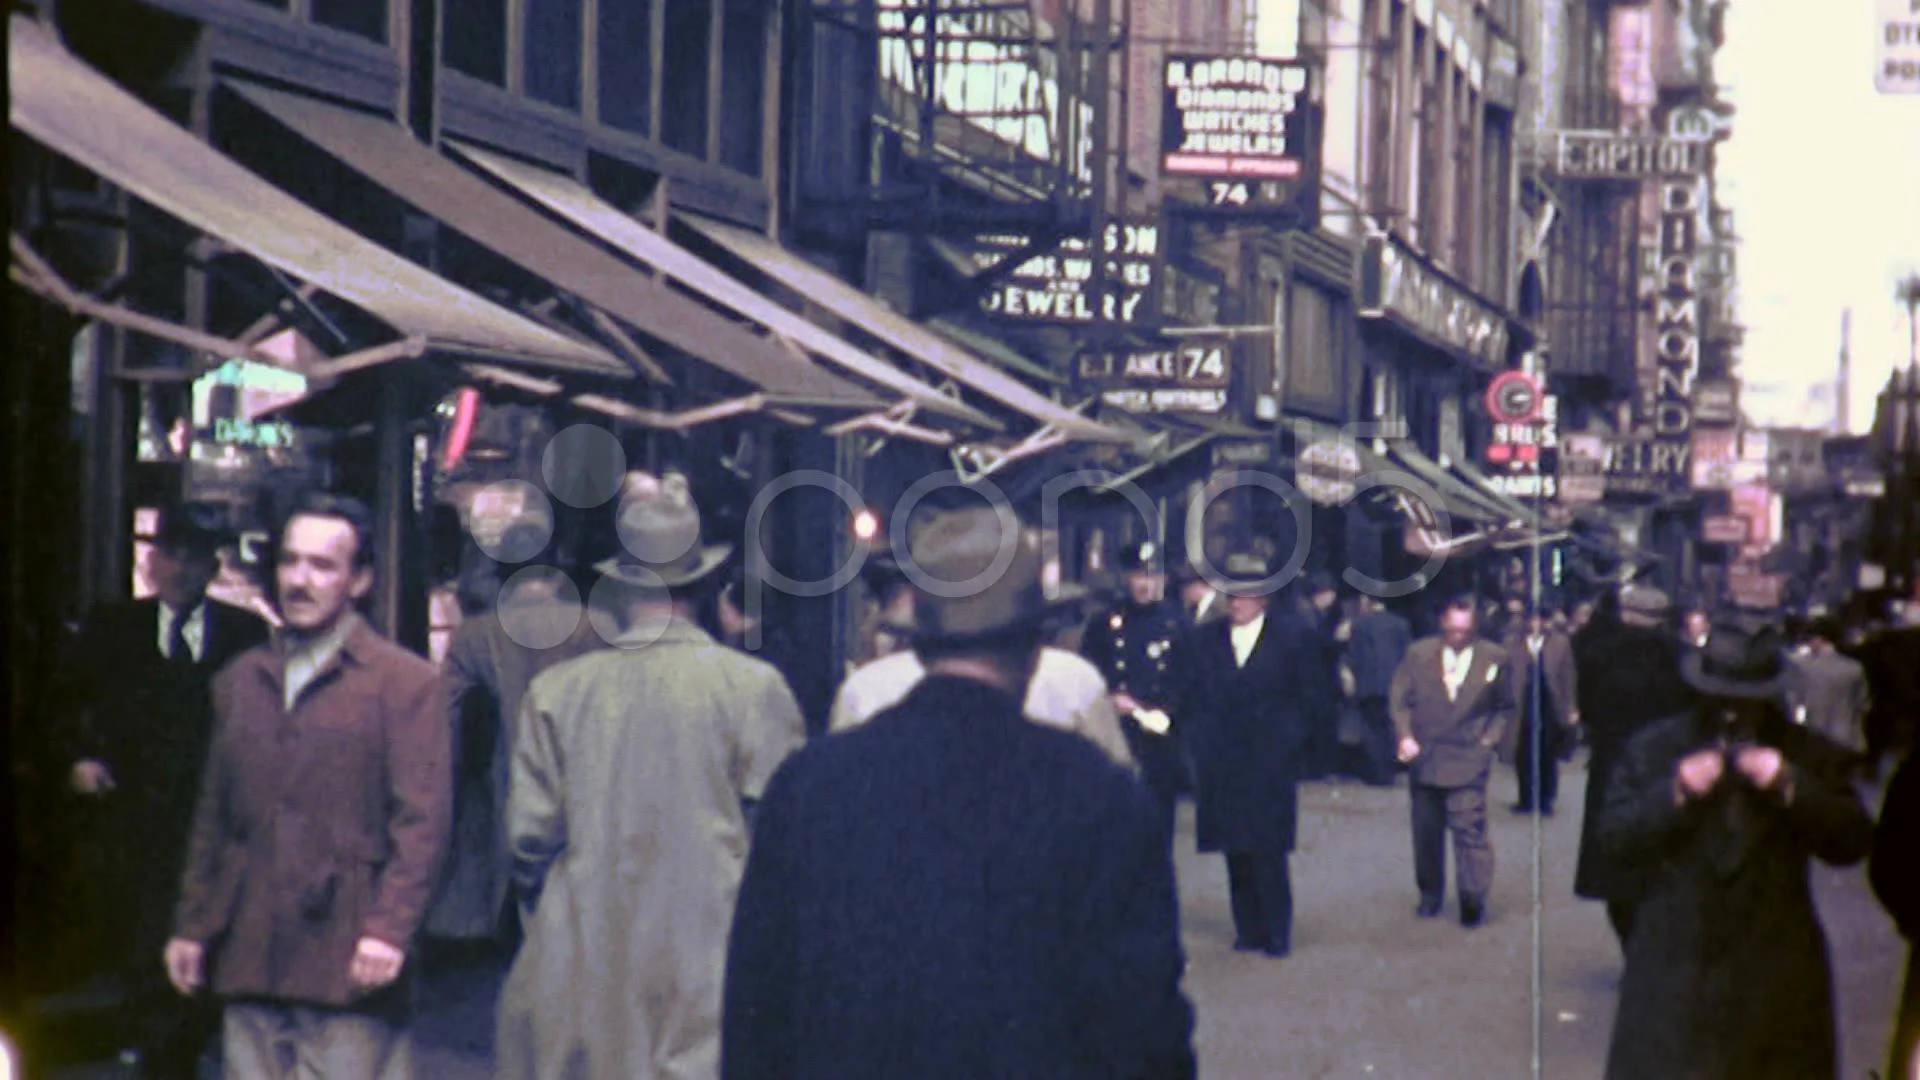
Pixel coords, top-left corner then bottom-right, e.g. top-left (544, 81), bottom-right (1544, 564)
top-left (1388, 636), bottom-right (1513, 788)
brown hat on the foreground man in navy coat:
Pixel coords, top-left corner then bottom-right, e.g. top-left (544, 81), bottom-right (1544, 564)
top-left (900, 507), bottom-right (1087, 644)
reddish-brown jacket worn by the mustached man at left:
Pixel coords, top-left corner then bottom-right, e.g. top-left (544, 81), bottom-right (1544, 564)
top-left (175, 623), bottom-right (453, 1007)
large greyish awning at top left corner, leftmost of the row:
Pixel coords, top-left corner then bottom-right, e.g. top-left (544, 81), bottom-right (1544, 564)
top-left (8, 15), bottom-right (632, 377)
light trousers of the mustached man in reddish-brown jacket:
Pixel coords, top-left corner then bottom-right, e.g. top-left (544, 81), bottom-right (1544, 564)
top-left (221, 1001), bottom-right (413, 1080)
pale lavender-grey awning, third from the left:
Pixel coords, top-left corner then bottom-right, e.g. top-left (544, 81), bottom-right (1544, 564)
top-left (447, 140), bottom-right (1000, 430)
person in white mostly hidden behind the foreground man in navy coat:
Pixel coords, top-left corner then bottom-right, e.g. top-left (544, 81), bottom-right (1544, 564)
top-left (828, 534), bottom-right (1137, 769)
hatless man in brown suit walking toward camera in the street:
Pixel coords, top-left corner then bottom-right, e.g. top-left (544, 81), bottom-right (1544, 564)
top-left (1392, 598), bottom-right (1513, 928)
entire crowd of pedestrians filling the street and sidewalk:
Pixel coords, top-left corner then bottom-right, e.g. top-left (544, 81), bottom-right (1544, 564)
top-left (26, 473), bottom-right (1920, 1080)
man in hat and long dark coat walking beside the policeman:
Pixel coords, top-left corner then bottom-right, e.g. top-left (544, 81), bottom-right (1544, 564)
top-left (1181, 553), bottom-right (1327, 957)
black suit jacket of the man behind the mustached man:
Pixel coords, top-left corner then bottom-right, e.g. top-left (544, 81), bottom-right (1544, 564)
top-left (63, 598), bottom-right (267, 883)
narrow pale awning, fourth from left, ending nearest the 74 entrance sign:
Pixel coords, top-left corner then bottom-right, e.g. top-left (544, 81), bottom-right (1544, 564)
top-left (682, 217), bottom-right (1131, 442)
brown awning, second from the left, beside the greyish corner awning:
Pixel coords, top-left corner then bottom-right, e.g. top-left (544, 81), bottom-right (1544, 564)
top-left (227, 81), bottom-right (881, 409)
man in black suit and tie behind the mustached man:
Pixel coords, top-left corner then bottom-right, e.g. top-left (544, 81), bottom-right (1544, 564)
top-left (67, 503), bottom-right (267, 1076)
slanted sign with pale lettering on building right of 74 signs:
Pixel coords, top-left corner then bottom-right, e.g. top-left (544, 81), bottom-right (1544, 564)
top-left (1357, 233), bottom-right (1507, 367)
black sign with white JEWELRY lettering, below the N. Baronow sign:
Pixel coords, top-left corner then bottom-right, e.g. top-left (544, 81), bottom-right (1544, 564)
top-left (972, 221), bottom-right (1162, 325)
